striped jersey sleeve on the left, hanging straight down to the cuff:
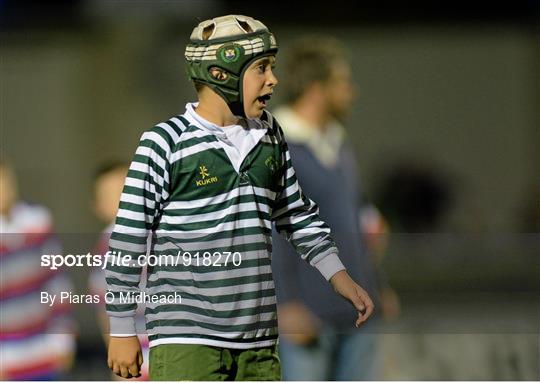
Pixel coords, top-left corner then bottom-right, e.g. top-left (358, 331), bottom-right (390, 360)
top-left (105, 124), bottom-right (179, 336)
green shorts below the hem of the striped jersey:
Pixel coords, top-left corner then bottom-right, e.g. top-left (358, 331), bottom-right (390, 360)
top-left (149, 344), bottom-right (281, 380)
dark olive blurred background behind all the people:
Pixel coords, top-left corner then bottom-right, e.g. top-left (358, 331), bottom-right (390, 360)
top-left (0, 0), bottom-right (540, 380)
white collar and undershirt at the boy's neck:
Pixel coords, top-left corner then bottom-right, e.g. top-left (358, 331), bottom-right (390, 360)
top-left (185, 103), bottom-right (266, 172)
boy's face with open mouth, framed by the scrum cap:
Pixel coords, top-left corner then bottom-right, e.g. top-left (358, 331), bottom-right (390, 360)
top-left (243, 56), bottom-right (278, 118)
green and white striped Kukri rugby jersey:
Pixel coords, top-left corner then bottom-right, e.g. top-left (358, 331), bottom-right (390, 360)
top-left (106, 104), bottom-right (344, 349)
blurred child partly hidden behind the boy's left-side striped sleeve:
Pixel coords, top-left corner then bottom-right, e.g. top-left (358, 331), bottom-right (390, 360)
top-left (89, 162), bottom-right (149, 380)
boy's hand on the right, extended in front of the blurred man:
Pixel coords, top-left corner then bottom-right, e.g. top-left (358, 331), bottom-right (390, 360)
top-left (330, 270), bottom-right (373, 327)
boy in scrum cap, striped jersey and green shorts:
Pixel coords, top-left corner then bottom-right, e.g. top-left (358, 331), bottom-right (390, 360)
top-left (106, 15), bottom-right (373, 380)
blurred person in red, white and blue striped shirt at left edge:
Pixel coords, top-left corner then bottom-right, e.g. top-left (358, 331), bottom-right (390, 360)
top-left (0, 161), bottom-right (75, 380)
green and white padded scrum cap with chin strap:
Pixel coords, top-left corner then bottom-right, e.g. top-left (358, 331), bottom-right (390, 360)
top-left (185, 15), bottom-right (278, 117)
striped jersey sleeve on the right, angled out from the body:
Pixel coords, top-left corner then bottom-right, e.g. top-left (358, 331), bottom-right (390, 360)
top-left (271, 114), bottom-right (345, 280)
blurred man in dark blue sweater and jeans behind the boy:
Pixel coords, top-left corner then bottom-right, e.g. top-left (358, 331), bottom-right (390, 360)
top-left (272, 36), bottom-right (398, 380)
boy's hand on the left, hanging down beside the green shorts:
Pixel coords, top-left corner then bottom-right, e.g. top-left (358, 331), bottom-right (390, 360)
top-left (107, 336), bottom-right (143, 379)
